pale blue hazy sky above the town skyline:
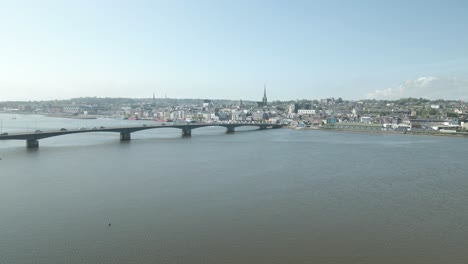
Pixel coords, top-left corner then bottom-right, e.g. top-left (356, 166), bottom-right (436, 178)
top-left (0, 0), bottom-right (468, 101)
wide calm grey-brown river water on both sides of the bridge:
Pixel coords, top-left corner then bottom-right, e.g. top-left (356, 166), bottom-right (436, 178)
top-left (0, 114), bottom-right (468, 264)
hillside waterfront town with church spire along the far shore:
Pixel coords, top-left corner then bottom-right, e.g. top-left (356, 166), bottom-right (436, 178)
top-left (0, 88), bottom-right (468, 134)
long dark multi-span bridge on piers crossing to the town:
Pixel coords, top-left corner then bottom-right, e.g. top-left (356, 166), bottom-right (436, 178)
top-left (0, 123), bottom-right (282, 148)
